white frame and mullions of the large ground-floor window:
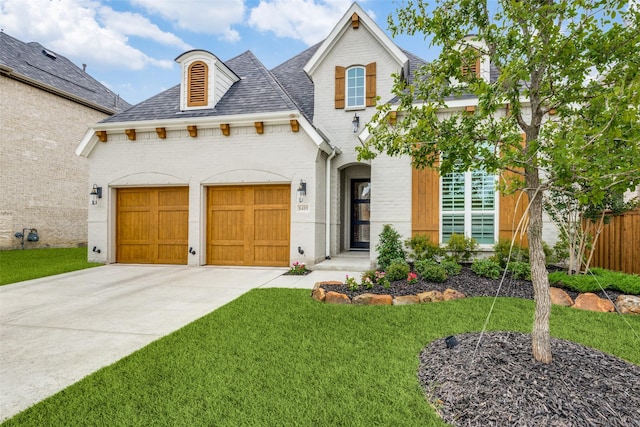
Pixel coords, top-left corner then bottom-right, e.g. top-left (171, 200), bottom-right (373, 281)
top-left (438, 169), bottom-right (500, 249)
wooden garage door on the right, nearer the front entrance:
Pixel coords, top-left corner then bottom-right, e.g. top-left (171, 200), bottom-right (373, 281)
top-left (207, 185), bottom-right (291, 267)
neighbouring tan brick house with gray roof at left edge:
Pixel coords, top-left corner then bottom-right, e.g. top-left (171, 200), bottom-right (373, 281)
top-left (0, 32), bottom-right (130, 249)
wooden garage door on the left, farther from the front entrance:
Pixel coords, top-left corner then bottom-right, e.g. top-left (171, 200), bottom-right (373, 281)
top-left (116, 187), bottom-right (189, 264)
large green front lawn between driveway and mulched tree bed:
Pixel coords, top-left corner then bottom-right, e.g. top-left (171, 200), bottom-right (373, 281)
top-left (6, 289), bottom-right (640, 426)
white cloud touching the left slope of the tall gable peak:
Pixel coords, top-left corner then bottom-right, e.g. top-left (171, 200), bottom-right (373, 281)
top-left (249, 0), bottom-right (374, 45)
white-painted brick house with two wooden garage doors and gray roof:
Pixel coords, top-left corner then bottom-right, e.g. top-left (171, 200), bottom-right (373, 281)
top-left (76, 3), bottom-right (544, 266)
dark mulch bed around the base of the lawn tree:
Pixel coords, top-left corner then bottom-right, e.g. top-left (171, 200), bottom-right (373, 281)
top-left (418, 332), bottom-right (640, 427)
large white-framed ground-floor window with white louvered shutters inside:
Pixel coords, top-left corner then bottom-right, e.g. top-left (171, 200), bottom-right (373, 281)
top-left (440, 170), bottom-right (496, 245)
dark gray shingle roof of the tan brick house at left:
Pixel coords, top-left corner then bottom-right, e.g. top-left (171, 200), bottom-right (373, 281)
top-left (0, 32), bottom-right (131, 113)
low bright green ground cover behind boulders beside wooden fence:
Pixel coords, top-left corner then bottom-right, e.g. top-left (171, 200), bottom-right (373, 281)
top-left (549, 268), bottom-right (640, 295)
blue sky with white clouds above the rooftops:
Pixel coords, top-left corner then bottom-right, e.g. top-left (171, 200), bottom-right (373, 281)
top-left (0, 0), bottom-right (434, 104)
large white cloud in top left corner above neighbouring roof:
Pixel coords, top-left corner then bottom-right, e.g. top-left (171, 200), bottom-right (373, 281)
top-left (0, 0), bottom-right (188, 70)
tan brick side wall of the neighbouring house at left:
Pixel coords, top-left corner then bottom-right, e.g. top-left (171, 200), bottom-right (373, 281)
top-left (0, 76), bottom-right (107, 249)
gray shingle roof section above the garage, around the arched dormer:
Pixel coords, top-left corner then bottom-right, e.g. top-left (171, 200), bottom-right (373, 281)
top-left (102, 51), bottom-right (298, 123)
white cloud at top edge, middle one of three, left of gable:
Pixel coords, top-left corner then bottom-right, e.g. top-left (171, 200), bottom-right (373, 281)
top-left (132, 0), bottom-right (245, 42)
